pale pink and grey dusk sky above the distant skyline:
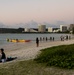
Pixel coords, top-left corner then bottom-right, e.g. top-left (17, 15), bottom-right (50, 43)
top-left (0, 0), bottom-right (74, 26)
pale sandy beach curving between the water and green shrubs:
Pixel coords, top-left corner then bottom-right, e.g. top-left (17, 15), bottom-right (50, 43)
top-left (4, 39), bottom-right (74, 60)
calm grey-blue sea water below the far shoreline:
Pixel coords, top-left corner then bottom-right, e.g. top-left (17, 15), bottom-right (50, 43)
top-left (0, 33), bottom-right (73, 47)
